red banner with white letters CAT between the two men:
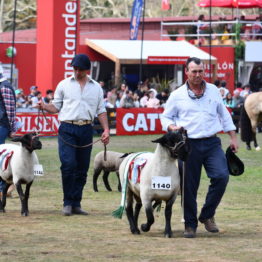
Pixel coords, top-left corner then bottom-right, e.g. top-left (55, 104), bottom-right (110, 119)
top-left (116, 108), bottom-right (165, 136)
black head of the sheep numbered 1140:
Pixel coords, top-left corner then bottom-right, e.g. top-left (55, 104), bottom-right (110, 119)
top-left (153, 128), bottom-right (189, 161)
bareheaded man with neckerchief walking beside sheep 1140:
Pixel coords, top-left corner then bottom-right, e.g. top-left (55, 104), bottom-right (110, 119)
top-left (161, 57), bottom-right (238, 238)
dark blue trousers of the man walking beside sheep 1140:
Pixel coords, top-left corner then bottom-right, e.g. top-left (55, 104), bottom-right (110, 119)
top-left (184, 137), bottom-right (229, 229)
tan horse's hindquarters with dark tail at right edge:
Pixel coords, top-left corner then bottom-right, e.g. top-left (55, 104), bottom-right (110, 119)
top-left (240, 92), bottom-right (262, 151)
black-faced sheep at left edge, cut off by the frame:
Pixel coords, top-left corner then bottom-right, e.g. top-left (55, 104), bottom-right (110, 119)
top-left (0, 133), bottom-right (42, 216)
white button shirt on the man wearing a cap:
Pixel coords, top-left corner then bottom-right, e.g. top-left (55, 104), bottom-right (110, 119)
top-left (52, 76), bottom-right (106, 121)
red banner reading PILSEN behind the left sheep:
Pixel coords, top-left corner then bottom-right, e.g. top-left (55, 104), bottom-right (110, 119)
top-left (16, 113), bottom-right (59, 136)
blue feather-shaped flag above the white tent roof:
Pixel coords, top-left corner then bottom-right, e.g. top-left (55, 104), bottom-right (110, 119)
top-left (129, 0), bottom-right (143, 40)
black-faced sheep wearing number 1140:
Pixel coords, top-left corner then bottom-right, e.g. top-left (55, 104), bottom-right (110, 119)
top-left (113, 128), bottom-right (189, 237)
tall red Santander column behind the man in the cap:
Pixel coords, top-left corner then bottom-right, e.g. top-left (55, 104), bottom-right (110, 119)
top-left (36, 0), bottom-right (80, 91)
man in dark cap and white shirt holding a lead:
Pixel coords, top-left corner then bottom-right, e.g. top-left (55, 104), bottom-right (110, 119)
top-left (38, 54), bottom-right (109, 216)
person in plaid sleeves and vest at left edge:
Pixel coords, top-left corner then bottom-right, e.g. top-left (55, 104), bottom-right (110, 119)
top-left (0, 65), bottom-right (17, 198)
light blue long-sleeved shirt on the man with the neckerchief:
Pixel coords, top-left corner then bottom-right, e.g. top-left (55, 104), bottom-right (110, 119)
top-left (160, 83), bottom-right (236, 138)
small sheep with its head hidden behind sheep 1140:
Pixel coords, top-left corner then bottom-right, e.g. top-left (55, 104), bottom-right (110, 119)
top-left (93, 151), bottom-right (129, 192)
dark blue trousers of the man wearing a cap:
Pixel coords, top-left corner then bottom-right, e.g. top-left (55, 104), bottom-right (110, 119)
top-left (58, 122), bottom-right (93, 207)
